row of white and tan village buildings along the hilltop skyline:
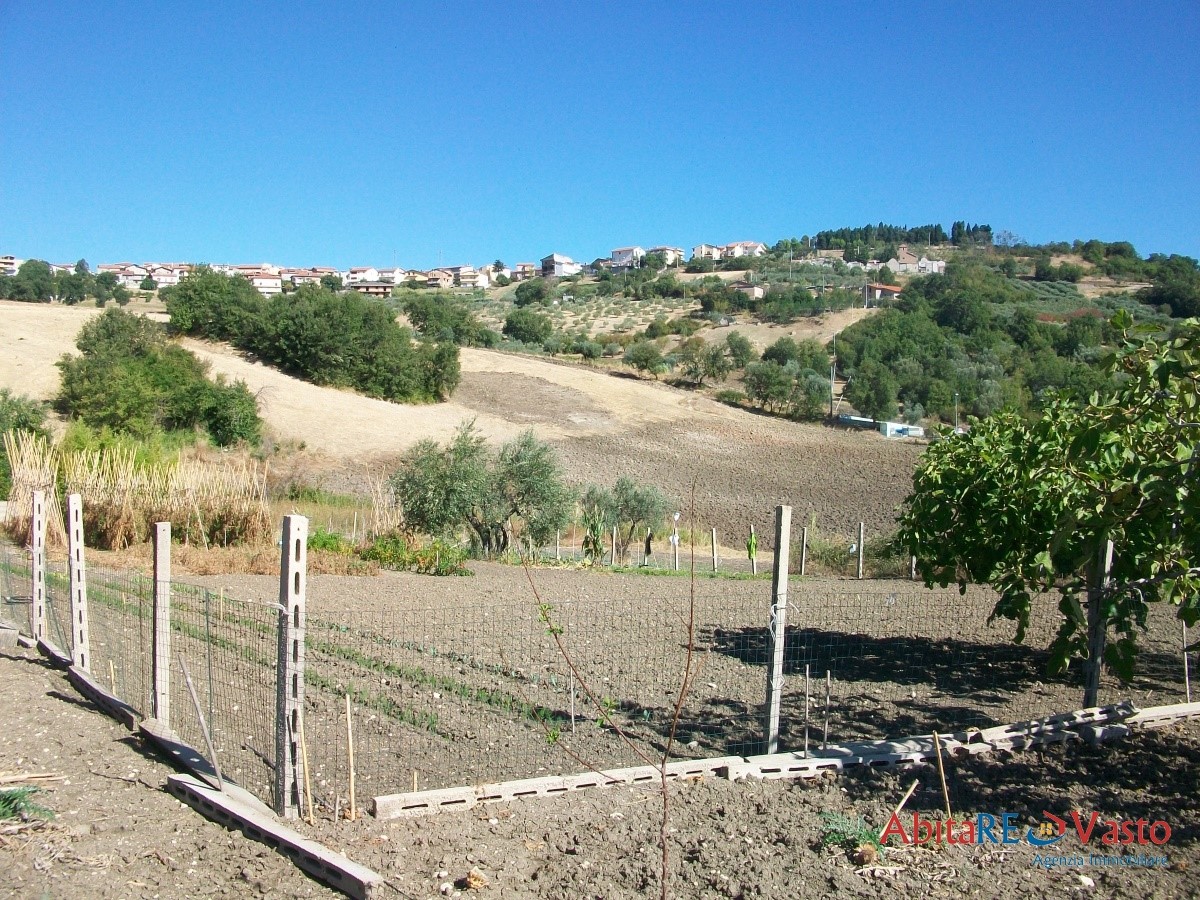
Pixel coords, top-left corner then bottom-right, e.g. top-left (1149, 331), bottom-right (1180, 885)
top-left (0, 241), bottom-right (946, 296)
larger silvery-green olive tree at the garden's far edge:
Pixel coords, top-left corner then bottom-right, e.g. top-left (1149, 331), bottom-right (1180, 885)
top-left (390, 421), bottom-right (575, 554)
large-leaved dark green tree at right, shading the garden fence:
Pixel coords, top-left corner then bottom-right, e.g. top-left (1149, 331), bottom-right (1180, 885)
top-left (899, 313), bottom-right (1200, 707)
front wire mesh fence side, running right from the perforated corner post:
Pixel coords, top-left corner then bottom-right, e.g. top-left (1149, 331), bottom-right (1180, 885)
top-left (297, 578), bottom-right (1184, 793)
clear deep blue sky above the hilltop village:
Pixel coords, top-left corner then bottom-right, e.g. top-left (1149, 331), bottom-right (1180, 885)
top-left (0, 0), bottom-right (1200, 268)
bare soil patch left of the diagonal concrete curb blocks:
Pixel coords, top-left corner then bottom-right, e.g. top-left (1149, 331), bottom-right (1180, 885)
top-left (0, 649), bottom-right (340, 900)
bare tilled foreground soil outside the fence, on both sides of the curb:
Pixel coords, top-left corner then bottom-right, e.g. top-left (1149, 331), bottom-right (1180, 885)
top-left (0, 633), bottom-right (1200, 899)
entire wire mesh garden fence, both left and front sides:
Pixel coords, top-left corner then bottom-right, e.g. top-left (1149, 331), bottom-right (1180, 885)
top-left (0, 535), bottom-right (1189, 809)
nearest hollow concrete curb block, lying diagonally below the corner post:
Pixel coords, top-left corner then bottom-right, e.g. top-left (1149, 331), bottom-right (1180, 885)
top-left (167, 775), bottom-right (384, 900)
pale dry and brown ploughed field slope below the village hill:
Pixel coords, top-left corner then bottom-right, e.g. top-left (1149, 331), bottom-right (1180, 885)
top-left (0, 302), bottom-right (920, 546)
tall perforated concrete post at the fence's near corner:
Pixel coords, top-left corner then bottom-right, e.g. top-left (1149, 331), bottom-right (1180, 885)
top-left (275, 516), bottom-right (308, 818)
